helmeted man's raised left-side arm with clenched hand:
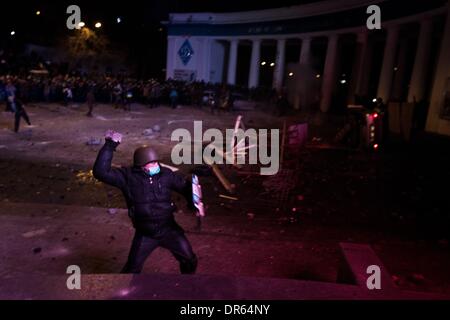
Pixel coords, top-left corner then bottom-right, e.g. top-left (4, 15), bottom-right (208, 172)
top-left (93, 132), bottom-right (126, 188)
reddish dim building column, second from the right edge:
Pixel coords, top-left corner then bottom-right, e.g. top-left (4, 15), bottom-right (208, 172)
top-left (408, 19), bottom-right (433, 102)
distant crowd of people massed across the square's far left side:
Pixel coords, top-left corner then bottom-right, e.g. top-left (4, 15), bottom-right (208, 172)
top-left (0, 50), bottom-right (285, 132)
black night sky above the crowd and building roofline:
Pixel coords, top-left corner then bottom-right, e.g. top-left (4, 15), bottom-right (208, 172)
top-left (0, 0), bottom-right (324, 76)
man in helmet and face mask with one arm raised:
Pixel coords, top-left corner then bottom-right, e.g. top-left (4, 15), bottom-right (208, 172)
top-left (93, 131), bottom-right (197, 274)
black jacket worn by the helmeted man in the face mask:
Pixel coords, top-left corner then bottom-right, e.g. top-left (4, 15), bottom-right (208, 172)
top-left (93, 139), bottom-right (194, 236)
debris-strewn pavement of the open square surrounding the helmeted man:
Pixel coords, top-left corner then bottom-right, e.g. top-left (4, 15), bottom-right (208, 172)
top-left (0, 104), bottom-right (450, 299)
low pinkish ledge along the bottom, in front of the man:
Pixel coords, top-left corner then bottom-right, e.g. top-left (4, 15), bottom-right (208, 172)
top-left (0, 274), bottom-right (450, 300)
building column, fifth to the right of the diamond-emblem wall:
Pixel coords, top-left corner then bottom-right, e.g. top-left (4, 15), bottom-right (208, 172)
top-left (320, 34), bottom-right (338, 112)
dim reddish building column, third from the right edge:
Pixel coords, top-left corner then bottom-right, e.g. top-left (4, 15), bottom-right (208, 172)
top-left (377, 26), bottom-right (399, 102)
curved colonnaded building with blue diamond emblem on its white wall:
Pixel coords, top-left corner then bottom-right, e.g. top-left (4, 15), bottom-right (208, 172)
top-left (165, 0), bottom-right (450, 135)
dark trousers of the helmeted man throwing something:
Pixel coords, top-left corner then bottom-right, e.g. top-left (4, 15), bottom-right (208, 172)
top-left (121, 230), bottom-right (197, 274)
